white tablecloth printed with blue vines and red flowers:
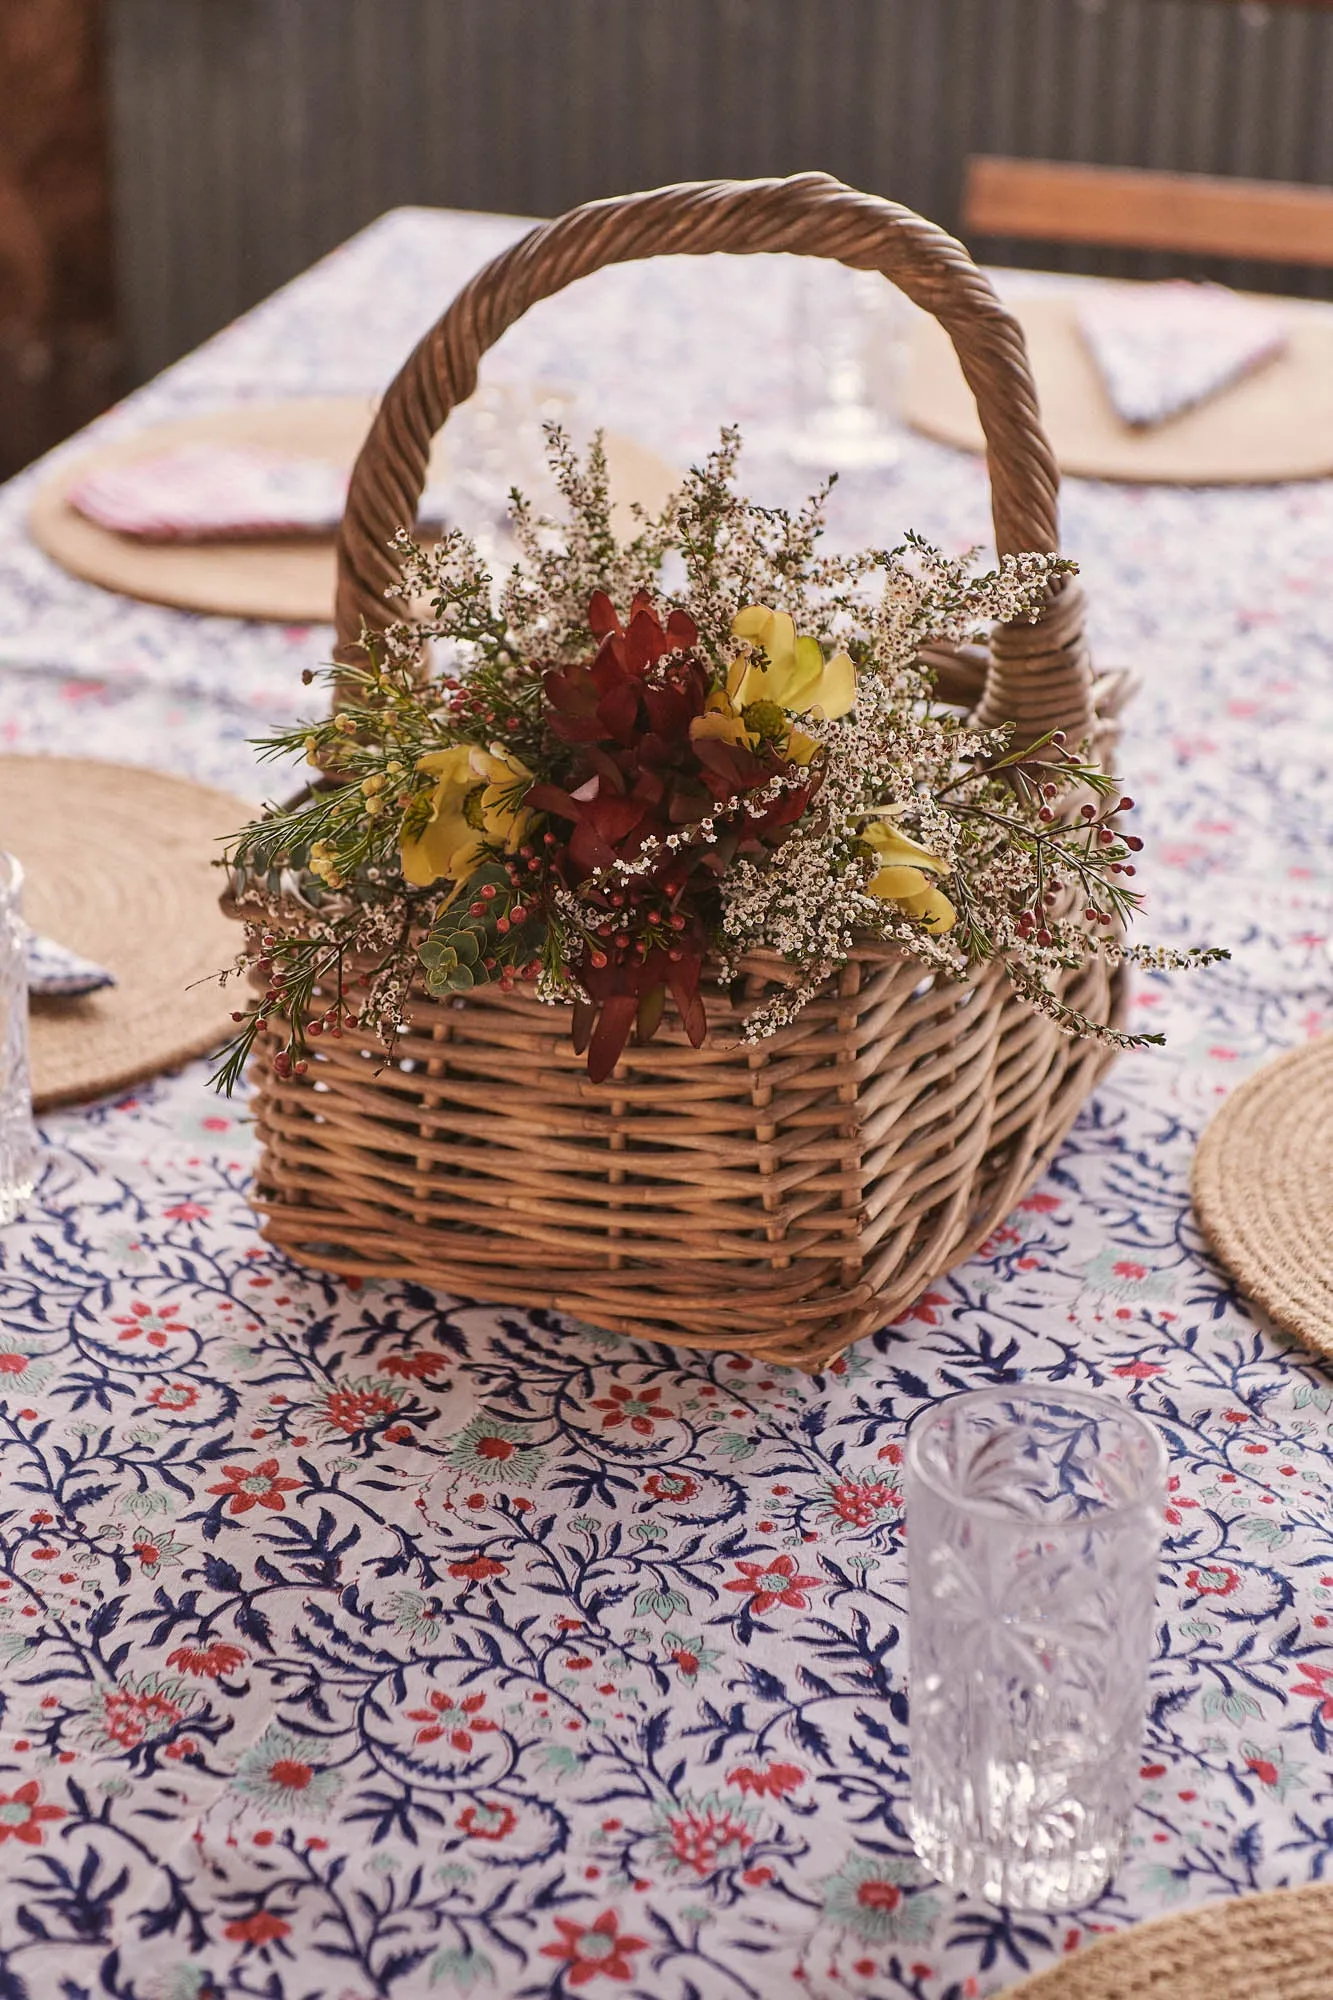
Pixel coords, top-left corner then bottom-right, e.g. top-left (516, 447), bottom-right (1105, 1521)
top-left (0, 210), bottom-right (1333, 2000)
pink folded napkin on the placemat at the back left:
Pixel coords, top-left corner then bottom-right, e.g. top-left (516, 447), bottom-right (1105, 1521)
top-left (68, 444), bottom-right (456, 542)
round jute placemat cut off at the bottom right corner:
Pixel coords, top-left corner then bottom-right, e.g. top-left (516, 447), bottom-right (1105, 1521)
top-left (1003, 1882), bottom-right (1333, 2000)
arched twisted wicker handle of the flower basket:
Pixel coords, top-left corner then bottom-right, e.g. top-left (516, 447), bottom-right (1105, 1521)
top-left (336, 174), bottom-right (1093, 742)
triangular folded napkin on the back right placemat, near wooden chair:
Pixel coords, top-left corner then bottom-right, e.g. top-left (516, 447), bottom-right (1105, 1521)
top-left (1079, 280), bottom-right (1287, 426)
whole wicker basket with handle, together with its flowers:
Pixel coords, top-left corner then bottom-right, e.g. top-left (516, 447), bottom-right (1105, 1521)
top-left (208, 174), bottom-right (1207, 1368)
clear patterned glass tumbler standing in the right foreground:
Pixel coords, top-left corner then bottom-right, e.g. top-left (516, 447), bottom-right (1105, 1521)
top-left (907, 1384), bottom-right (1167, 1910)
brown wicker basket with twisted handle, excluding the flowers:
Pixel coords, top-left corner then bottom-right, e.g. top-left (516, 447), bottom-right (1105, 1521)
top-left (236, 174), bottom-right (1117, 1368)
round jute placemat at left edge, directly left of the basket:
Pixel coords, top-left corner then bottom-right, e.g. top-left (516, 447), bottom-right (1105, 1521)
top-left (0, 756), bottom-right (252, 1110)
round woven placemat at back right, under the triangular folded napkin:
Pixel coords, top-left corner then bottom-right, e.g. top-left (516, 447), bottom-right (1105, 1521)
top-left (903, 294), bottom-right (1333, 484)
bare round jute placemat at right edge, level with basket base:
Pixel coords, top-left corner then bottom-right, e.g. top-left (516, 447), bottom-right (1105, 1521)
top-left (1193, 1034), bottom-right (1333, 1360)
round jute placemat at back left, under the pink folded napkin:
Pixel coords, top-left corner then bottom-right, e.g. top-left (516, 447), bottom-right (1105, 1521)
top-left (28, 396), bottom-right (679, 624)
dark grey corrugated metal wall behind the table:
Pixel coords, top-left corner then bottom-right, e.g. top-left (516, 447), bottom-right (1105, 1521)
top-left (110, 0), bottom-right (1333, 378)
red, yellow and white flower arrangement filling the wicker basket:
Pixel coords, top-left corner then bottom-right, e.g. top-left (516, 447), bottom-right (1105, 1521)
top-left (220, 426), bottom-right (1197, 1086)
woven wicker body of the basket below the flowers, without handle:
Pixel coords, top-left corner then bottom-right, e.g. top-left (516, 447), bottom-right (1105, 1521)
top-left (241, 948), bottom-right (1127, 1372)
